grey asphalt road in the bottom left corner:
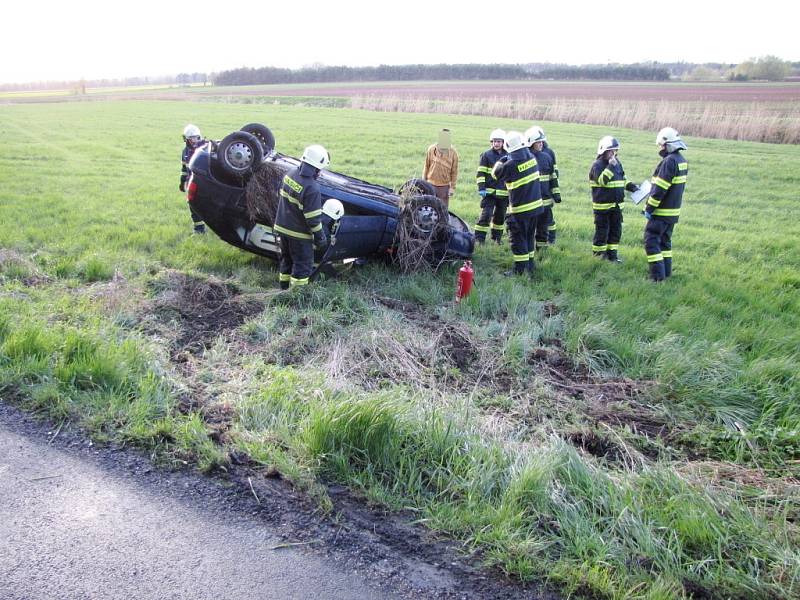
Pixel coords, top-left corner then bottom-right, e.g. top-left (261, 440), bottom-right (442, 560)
top-left (0, 403), bottom-right (396, 600)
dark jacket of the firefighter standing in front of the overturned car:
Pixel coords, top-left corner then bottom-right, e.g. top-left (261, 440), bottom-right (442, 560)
top-left (275, 163), bottom-right (322, 240)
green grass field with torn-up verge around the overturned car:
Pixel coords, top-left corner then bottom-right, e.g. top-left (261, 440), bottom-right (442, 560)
top-left (0, 101), bottom-right (800, 598)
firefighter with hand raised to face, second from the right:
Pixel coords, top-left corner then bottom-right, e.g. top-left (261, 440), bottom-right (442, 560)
top-left (589, 135), bottom-right (639, 262)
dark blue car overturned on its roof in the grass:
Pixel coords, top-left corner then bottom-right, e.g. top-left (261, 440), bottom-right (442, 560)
top-left (187, 123), bottom-right (475, 270)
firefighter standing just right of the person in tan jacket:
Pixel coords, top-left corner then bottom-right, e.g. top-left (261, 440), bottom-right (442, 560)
top-left (475, 129), bottom-right (508, 244)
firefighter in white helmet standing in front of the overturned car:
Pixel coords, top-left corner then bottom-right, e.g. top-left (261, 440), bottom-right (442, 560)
top-left (275, 144), bottom-right (331, 290)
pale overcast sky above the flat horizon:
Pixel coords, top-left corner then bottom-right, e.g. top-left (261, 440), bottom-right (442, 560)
top-left (0, 0), bottom-right (800, 83)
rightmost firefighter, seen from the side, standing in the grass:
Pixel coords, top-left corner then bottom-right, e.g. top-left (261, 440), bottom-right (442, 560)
top-left (642, 127), bottom-right (689, 281)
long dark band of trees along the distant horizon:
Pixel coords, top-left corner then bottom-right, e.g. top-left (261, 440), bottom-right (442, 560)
top-left (211, 64), bottom-right (670, 85)
